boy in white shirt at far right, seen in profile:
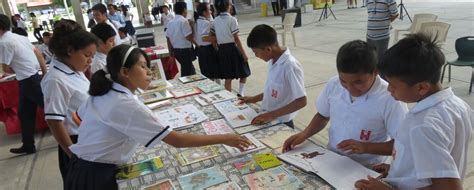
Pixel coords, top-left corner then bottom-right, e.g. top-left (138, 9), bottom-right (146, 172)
top-left (355, 34), bottom-right (474, 190)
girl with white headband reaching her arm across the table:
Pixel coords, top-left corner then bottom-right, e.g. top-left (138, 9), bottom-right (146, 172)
top-left (64, 45), bottom-right (249, 190)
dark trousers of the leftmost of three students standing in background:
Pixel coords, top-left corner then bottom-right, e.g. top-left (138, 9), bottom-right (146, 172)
top-left (173, 48), bottom-right (196, 77)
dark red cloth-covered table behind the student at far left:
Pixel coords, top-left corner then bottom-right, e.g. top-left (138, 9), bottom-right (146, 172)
top-left (0, 80), bottom-right (48, 135)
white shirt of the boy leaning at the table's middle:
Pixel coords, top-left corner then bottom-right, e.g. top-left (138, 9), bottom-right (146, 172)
top-left (262, 49), bottom-right (306, 122)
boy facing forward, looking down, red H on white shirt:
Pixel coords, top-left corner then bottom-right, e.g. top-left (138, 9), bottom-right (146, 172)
top-left (283, 40), bottom-right (408, 168)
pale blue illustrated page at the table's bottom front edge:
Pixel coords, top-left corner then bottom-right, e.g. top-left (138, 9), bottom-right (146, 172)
top-left (178, 167), bottom-right (227, 189)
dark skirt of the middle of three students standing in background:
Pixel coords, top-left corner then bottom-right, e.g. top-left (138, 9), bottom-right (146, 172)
top-left (197, 45), bottom-right (219, 79)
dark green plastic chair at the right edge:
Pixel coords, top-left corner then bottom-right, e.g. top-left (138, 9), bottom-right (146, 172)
top-left (441, 36), bottom-right (474, 94)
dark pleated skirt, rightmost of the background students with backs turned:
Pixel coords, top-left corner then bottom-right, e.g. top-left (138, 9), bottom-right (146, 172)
top-left (217, 43), bottom-right (251, 79)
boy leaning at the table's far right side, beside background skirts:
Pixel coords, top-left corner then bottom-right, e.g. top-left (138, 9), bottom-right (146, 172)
top-left (241, 24), bottom-right (306, 128)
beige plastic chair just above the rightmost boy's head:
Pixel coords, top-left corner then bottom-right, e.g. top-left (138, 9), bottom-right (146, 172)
top-left (419, 22), bottom-right (451, 45)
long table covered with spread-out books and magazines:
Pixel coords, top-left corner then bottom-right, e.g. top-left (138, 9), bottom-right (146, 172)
top-left (117, 75), bottom-right (378, 189)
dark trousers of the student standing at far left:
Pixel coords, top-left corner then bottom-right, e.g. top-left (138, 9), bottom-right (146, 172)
top-left (18, 74), bottom-right (44, 148)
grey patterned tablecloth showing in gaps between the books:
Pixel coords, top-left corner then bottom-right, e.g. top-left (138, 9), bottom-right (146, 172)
top-left (119, 79), bottom-right (331, 190)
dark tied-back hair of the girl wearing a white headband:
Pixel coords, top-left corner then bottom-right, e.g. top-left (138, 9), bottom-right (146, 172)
top-left (89, 44), bottom-right (150, 96)
